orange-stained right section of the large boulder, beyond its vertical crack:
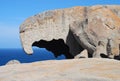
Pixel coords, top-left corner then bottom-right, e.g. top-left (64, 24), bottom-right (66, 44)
top-left (70, 6), bottom-right (120, 55)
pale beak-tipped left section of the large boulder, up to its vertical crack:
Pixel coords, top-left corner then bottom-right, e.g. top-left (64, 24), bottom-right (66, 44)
top-left (20, 7), bottom-right (85, 56)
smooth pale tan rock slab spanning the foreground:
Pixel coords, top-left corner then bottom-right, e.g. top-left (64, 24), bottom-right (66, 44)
top-left (0, 58), bottom-right (120, 81)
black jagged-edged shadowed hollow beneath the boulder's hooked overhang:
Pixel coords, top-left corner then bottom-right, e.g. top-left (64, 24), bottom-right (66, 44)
top-left (32, 39), bottom-right (74, 59)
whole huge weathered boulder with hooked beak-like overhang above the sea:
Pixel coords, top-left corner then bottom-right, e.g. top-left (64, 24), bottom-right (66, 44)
top-left (20, 5), bottom-right (120, 58)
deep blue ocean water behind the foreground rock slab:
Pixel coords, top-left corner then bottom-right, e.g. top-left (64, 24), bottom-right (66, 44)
top-left (0, 48), bottom-right (65, 66)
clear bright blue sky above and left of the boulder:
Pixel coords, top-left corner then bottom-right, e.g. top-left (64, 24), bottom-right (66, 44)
top-left (0, 0), bottom-right (120, 48)
